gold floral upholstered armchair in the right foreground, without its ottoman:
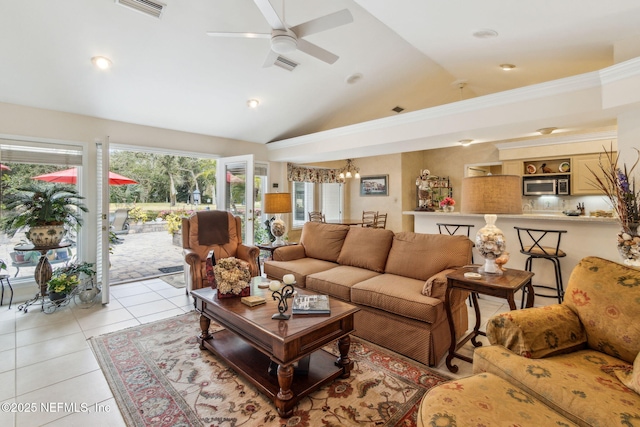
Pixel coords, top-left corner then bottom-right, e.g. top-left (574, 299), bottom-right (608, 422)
top-left (473, 257), bottom-right (640, 426)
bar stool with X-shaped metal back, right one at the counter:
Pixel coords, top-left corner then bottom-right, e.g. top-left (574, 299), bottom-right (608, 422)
top-left (513, 227), bottom-right (567, 307)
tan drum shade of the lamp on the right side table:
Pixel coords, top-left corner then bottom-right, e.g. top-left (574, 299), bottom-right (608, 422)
top-left (462, 175), bottom-right (522, 214)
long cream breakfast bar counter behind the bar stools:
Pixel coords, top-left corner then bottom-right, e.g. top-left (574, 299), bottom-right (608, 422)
top-left (402, 211), bottom-right (621, 305)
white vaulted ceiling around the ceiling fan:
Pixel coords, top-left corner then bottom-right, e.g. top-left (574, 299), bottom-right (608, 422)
top-left (0, 0), bottom-right (640, 151)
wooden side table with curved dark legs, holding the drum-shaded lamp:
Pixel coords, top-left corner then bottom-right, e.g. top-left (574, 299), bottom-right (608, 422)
top-left (444, 266), bottom-right (534, 373)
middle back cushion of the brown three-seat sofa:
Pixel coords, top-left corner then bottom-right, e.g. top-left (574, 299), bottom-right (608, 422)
top-left (338, 227), bottom-right (393, 273)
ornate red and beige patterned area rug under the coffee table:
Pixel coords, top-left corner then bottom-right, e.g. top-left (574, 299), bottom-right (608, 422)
top-left (90, 312), bottom-right (448, 427)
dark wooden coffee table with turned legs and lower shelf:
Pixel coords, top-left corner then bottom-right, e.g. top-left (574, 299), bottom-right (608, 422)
top-left (191, 280), bottom-right (359, 418)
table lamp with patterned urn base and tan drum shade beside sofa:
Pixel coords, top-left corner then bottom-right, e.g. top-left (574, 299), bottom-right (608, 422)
top-left (462, 175), bottom-right (522, 274)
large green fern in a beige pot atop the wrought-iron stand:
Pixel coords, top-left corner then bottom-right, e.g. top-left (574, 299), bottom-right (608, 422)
top-left (1, 182), bottom-right (89, 247)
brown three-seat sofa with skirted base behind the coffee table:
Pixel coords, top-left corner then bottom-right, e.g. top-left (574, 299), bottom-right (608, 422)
top-left (264, 222), bottom-right (472, 366)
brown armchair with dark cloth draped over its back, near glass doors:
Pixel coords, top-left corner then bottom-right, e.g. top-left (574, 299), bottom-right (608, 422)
top-left (182, 211), bottom-right (260, 292)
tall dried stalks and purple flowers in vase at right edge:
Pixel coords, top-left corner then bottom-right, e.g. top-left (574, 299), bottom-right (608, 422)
top-left (589, 147), bottom-right (640, 235)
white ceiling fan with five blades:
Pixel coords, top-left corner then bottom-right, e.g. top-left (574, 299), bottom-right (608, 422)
top-left (207, 0), bottom-right (353, 67)
